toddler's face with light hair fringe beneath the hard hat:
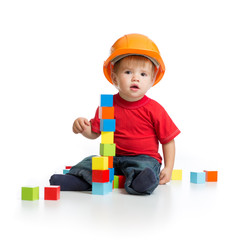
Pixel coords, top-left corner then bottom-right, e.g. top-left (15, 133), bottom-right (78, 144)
top-left (111, 58), bottom-right (154, 102)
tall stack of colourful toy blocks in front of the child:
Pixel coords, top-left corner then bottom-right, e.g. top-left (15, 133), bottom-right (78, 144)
top-left (92, 94), bottom-right (116, 195)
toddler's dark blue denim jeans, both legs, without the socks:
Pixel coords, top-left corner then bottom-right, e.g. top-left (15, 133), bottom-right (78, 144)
top-left (68, 155), bottom-right (161, 195)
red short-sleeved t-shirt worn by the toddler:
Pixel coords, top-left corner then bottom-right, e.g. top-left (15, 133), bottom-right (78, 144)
top-left (91, 94), bottom-right (180, 163)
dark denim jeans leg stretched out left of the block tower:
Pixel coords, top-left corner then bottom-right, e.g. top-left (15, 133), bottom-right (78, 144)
top-left (67, 155), bottom-right (95, 185)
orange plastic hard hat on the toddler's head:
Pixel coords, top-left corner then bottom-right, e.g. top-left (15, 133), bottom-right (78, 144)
top-left (103, 34), bottom-right (165, 86)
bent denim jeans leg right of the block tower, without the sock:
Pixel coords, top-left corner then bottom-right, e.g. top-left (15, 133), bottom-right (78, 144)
top-left (117, 155), bottom-right (161, 195)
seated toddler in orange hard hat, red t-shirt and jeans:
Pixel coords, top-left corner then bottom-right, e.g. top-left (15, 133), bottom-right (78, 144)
top-left (50, 34), bottom-right (180, 195)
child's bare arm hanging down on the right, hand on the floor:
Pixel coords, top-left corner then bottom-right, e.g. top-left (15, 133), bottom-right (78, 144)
top-left (159, 140), bottom-right (175, 184)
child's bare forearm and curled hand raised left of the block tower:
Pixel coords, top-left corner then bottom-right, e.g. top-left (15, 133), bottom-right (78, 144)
top-left (72, 117), bottom-right (100, 139)
